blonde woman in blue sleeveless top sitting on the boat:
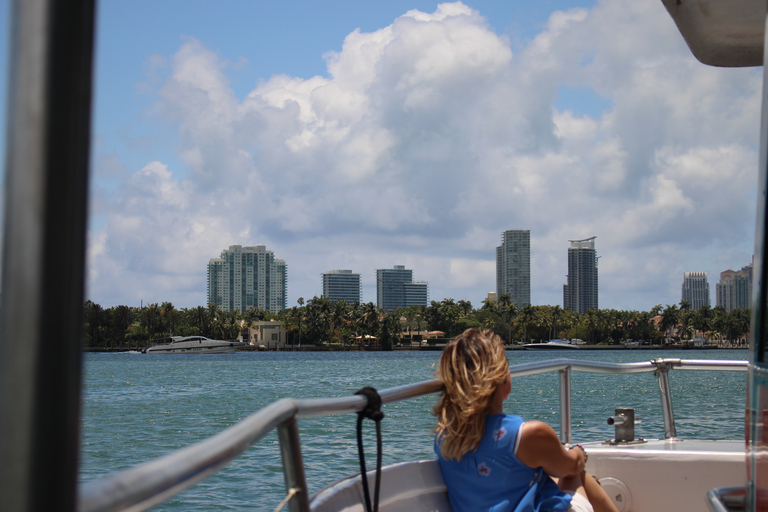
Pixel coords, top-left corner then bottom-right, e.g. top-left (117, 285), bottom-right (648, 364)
top-left (434, 329), bottom-right (617, 512)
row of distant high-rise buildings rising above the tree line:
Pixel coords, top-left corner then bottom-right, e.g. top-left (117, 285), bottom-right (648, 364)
top-left (108, 229), bottom-right (752, 313)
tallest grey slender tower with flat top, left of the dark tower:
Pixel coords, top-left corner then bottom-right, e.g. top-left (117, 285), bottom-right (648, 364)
top-left (496, 229), bottom-right (531, 307)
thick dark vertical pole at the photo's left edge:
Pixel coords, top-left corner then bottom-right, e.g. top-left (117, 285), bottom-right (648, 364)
top-left (0, 0), bottom-right (94, 512)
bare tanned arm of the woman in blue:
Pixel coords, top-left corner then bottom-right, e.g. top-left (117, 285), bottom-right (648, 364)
top-left (517, 421), bottom-right (586, 478)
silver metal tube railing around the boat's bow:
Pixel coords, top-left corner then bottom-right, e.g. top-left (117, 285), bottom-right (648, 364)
top-left (78, 359), bottom-right (747, 512)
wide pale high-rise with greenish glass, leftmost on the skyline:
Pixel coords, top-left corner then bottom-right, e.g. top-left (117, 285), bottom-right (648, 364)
top-left (208, 245), bottom-right (287, 313)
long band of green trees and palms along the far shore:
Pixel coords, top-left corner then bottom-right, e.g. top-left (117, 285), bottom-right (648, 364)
top-left (83, 294), bottom-right (750, 350)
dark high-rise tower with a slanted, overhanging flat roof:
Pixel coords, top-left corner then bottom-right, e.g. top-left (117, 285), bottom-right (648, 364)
top-left (563, 236), bottom-right (597, 313)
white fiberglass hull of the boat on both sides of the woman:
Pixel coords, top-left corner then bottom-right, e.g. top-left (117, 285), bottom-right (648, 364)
top-left (310, 440), bottom-right (746, 512)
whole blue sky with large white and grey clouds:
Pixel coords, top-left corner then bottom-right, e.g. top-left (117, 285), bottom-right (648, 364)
top-left (0, 0), bottom-right (762, 311)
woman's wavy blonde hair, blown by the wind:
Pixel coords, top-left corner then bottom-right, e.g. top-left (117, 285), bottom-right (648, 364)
top-left (434, 329), bottom-right (509, 460)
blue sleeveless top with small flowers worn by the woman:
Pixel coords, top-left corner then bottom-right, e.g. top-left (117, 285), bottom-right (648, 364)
top-left (435, 414), bottom-right (571, 512)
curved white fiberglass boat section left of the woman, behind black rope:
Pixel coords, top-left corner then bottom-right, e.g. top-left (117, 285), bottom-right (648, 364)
top-left (309, 460), bottom-right (451, 512)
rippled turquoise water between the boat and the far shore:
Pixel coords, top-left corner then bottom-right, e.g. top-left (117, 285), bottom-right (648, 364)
top-left (81, 350), bottom-right (747, 511)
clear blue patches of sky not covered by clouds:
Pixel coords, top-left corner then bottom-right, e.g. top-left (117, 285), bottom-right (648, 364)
top-left (87, 0), bottom-right (602, 194)
